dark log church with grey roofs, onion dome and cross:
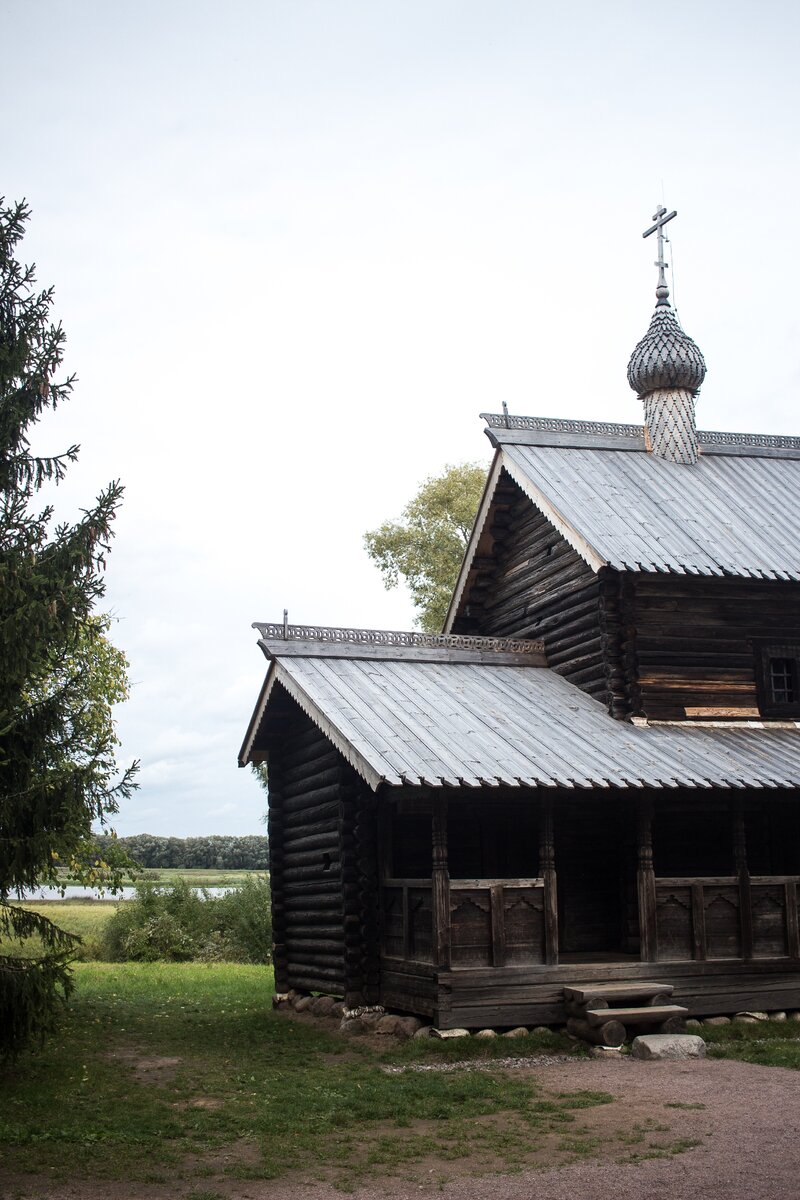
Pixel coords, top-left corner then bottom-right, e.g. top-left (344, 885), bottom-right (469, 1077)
top-left (240, 209), bottom-right (800, 1028)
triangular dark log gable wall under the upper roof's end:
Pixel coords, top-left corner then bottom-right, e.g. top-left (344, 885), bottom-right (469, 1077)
top-left (453, 474), bottom-right (616, 703)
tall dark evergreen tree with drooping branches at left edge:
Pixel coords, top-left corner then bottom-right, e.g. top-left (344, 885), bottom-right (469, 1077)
top-left (0, 199), bottom-right (136, 1054)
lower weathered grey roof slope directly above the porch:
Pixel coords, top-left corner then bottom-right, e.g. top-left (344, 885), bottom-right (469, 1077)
top-left (248, 654), bottom-right (800, 788)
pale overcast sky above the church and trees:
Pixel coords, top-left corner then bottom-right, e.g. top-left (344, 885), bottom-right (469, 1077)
top-left (6, 0), bottom-right (800, 835)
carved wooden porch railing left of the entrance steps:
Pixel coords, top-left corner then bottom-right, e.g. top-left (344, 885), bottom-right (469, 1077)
top-left (383, 878), bottom-right (546, 968)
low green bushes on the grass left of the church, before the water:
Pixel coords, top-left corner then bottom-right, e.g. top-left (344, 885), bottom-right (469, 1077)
top-left (102, 876), bottom-right (272, 962)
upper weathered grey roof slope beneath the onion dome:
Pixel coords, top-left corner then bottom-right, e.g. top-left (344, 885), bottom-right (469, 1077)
top-left (501, 439), bottom-right (800, 580)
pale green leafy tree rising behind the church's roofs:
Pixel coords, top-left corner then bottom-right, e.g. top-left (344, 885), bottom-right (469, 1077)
top-left (363, 462), bottom-right (486, 634)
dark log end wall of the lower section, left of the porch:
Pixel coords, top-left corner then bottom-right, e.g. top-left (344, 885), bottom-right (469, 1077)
top-left (269, 695), bottom-right (378, 1003)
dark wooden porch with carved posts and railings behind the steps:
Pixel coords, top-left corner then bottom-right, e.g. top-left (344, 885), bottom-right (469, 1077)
top-left (380, 794), bottom-right (800, 1027)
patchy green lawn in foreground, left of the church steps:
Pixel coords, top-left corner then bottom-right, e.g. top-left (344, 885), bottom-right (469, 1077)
top-left (0, 962), bottom-right (612, 1195)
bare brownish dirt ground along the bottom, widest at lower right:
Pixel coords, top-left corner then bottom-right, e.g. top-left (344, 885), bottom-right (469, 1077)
top-left (6, 1058), bottom-right (800, 1200)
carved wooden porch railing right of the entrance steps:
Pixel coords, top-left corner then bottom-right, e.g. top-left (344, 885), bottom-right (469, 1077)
top-left (655, 875), bottom-right (800, 961)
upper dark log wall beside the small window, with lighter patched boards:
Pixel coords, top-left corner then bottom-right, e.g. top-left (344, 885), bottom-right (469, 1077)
top-left (620, 575), bottom-right (800, 720)
